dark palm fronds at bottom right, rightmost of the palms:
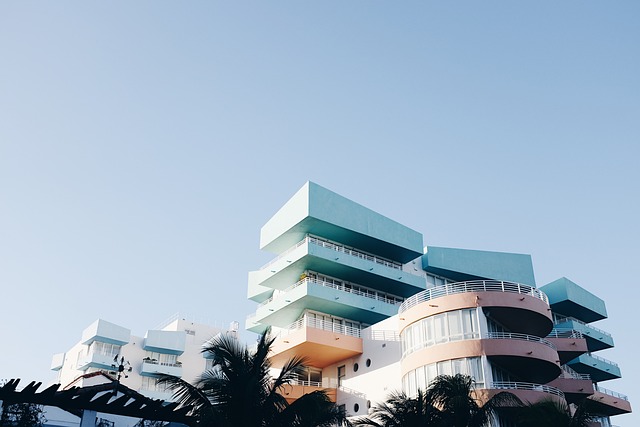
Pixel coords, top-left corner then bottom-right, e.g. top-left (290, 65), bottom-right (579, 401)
top-left (518, 399), bottom-right (597, 427)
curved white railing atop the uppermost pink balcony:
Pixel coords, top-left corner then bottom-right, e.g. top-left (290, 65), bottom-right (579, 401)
top-left (399, 280), bottom-right (549, 313)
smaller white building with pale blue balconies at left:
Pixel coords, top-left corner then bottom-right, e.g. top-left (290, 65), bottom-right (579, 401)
top-left (51, 314), bottom-right (238, 401)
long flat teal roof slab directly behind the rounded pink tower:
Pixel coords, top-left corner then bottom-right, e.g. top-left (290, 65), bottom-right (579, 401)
top-left (422, 246), bottom-right (536, 286)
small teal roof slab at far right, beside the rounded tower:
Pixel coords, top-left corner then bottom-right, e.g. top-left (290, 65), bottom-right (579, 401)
top-left (540, 277), bottom-right (607, 323)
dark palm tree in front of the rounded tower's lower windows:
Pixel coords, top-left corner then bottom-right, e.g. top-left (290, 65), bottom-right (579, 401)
top-left (426, 374), bottom-right (521, 427)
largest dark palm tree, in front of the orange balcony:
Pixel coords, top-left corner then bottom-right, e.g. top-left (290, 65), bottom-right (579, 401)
top-left (159, 331), bottom-right (344, 427)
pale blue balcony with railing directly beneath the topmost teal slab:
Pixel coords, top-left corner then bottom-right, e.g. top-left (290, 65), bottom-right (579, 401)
top-left (249, 236), bottom-right (426, 297)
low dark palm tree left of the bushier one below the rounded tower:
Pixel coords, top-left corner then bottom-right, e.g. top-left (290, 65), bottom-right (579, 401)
top-left (351, 390), bottom-right (440, 427)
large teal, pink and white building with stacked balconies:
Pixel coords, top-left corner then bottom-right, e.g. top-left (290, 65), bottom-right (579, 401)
top-left (246, 182), bottom-right (631, 426)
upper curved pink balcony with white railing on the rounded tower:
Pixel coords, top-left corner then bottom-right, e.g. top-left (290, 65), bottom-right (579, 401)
top-left (399, 280), bottom-right (553, 337)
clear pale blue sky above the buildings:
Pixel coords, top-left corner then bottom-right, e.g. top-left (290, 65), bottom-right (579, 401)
top-left (0, 0), bottom-right (640, 427)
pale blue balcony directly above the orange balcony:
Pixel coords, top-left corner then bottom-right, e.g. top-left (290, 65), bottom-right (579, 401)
top-left (247, 277), bottom-right (402, 332)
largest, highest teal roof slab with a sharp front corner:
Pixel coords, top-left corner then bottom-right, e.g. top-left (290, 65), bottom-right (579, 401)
top-left (260, 181), bottom-right (423, 263)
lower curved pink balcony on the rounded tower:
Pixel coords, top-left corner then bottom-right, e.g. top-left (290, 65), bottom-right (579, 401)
top-left (401, 333), bottom-right (561, 383)
